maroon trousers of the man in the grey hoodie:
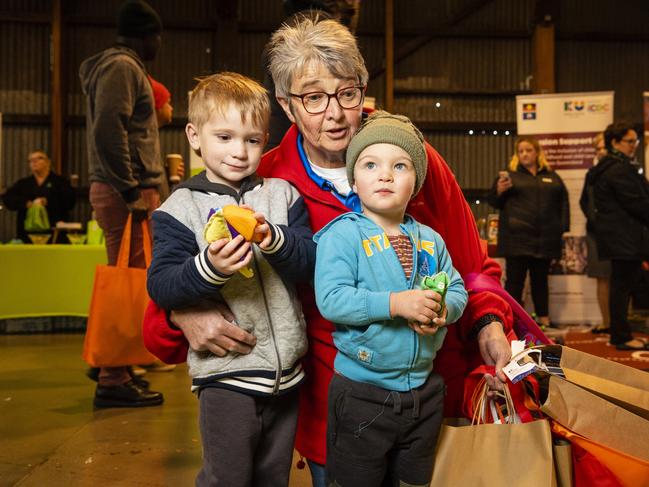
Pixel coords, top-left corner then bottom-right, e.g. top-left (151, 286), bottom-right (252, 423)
top-left (89, 182), bottom-right (160, 387)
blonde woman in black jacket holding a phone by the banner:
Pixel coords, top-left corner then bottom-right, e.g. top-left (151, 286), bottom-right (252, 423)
top-left (487, 136), bottom-right (570, 327)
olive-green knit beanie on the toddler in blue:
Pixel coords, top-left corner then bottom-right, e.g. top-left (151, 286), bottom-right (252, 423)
top-left (345, 110), bottom-right (428, 197)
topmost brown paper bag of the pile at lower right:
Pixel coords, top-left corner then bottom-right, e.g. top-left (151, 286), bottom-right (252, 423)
top-left (539, 345), bottom-right (649, 419)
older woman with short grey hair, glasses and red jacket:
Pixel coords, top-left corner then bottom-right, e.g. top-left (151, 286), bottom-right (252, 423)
top-left (145, 16), bottom-right (512, 485)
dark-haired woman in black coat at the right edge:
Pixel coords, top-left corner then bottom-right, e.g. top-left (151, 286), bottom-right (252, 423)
top-left (588, 122), bottom-right (649, 350)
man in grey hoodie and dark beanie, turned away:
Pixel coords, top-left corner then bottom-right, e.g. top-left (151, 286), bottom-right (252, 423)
top-left (79, 0), bottom-right (164, 407)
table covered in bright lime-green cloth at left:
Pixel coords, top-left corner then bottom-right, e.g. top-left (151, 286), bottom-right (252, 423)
top-left (0, 245), bottom-right (106, 319)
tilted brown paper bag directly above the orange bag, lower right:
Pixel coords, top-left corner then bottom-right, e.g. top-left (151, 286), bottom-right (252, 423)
top-left (540, 375), bottom-right (649, 461)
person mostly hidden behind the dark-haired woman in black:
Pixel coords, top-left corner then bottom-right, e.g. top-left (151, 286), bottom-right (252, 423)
top-left (579, 132), bottom-right (611, 333)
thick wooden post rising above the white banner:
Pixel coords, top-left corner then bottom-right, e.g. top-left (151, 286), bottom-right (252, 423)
top-left (532, 17), bottom-right (556, 93)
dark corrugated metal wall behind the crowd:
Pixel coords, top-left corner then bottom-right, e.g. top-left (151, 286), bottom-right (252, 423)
top-left (0, 0), bottom-right (649, 240)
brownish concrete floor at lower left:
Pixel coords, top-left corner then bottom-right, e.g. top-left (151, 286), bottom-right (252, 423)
top-left (0, 334), bottom-right (310, 487)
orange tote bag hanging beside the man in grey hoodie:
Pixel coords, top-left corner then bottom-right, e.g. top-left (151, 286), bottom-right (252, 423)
top-left (82, 215), bottom-right (155, 367)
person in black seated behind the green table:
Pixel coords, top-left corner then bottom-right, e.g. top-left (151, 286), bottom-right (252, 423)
top-left (2, 150), bottom-right (76, 243)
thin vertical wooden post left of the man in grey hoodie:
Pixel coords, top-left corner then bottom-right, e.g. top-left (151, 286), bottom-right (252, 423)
top-left (50, 0), bottom-right (64, 174)
